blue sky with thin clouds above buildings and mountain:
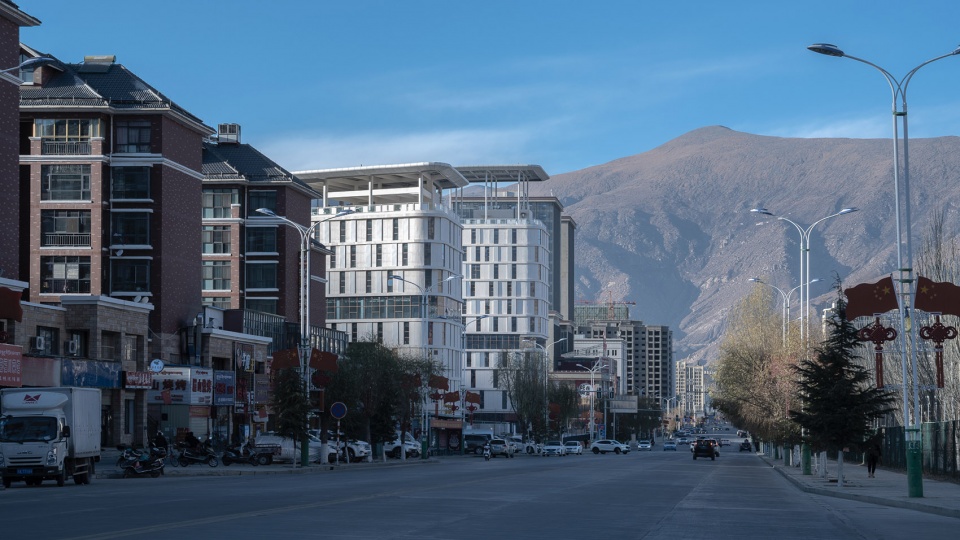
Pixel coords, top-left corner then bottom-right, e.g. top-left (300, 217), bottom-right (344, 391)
top-left (17, 0), bottom-right (960, 174)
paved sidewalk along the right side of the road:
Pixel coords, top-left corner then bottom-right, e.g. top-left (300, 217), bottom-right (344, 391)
top-left (759, 454), bottom-right (960, 518)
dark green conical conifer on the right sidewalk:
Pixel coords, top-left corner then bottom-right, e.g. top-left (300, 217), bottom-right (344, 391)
top-left (791, 280), bottom-right (893, 483)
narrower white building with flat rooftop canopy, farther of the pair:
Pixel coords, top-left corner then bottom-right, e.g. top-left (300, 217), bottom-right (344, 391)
top-left (454, 165), bottom-right (562, 430)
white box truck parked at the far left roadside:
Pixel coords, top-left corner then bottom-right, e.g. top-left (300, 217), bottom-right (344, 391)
top-left (0, 388), bottom-right (100, 487)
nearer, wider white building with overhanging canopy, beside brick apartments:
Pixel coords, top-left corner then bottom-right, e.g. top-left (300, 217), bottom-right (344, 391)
top-left (294, 162), bottom-right (467, 391)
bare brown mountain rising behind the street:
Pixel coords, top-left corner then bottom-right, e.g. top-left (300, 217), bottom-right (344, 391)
top-left (534, 126), bottom-right (960, 362)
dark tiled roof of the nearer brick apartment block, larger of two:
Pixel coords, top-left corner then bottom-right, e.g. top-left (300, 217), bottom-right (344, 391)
top-left (20, 56), bottom-right (203, 124)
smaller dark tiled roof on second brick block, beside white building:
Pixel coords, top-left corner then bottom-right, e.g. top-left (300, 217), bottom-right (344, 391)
top-left (202, 142), bottom-right (311, 193)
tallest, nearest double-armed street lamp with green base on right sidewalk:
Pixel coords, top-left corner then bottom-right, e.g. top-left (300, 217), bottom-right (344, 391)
top-left (807, 43), bottom-right (960, 497)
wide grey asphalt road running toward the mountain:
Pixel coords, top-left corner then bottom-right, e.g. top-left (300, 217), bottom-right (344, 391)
top-left (0, 441), bottom-right (960, 540)
